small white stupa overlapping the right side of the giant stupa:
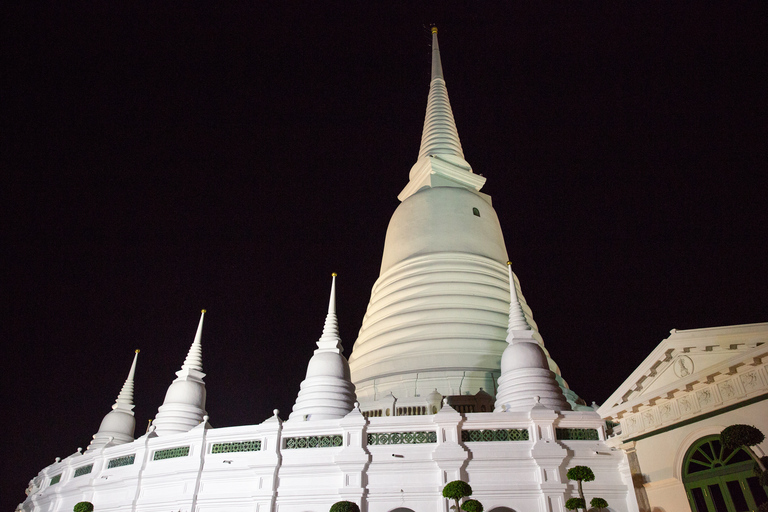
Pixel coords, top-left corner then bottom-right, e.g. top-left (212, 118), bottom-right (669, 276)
top-left (494, 262), bottom-right (571, 412)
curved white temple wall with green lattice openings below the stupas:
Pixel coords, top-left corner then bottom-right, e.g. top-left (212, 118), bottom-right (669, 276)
top-left (20, 406), bottom-right (637, 512)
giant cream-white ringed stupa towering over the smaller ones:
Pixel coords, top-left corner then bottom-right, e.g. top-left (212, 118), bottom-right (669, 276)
top-left (349, 28), bottom-right (578, 408)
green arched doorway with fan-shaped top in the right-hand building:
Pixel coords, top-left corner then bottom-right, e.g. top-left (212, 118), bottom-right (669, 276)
top-left (682, 435), bottom-right (768, 512)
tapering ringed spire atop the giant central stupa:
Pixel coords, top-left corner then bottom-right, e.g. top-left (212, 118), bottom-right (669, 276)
top-left (419, 27), bottom-right (464, 160)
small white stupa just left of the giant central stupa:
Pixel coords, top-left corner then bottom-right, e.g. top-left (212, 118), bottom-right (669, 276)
top-left (288, 273), bottom-right (355, 421)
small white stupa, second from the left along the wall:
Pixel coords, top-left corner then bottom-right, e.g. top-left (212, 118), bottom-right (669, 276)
top-left (152, 310), bottom-right (207, 436)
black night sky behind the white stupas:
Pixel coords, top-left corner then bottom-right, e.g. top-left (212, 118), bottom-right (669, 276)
top-left (0, 2), bottom-right (768, 510)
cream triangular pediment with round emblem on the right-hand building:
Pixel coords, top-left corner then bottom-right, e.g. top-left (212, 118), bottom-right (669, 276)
top-left (599, 323), bottom-right (768, 418)
